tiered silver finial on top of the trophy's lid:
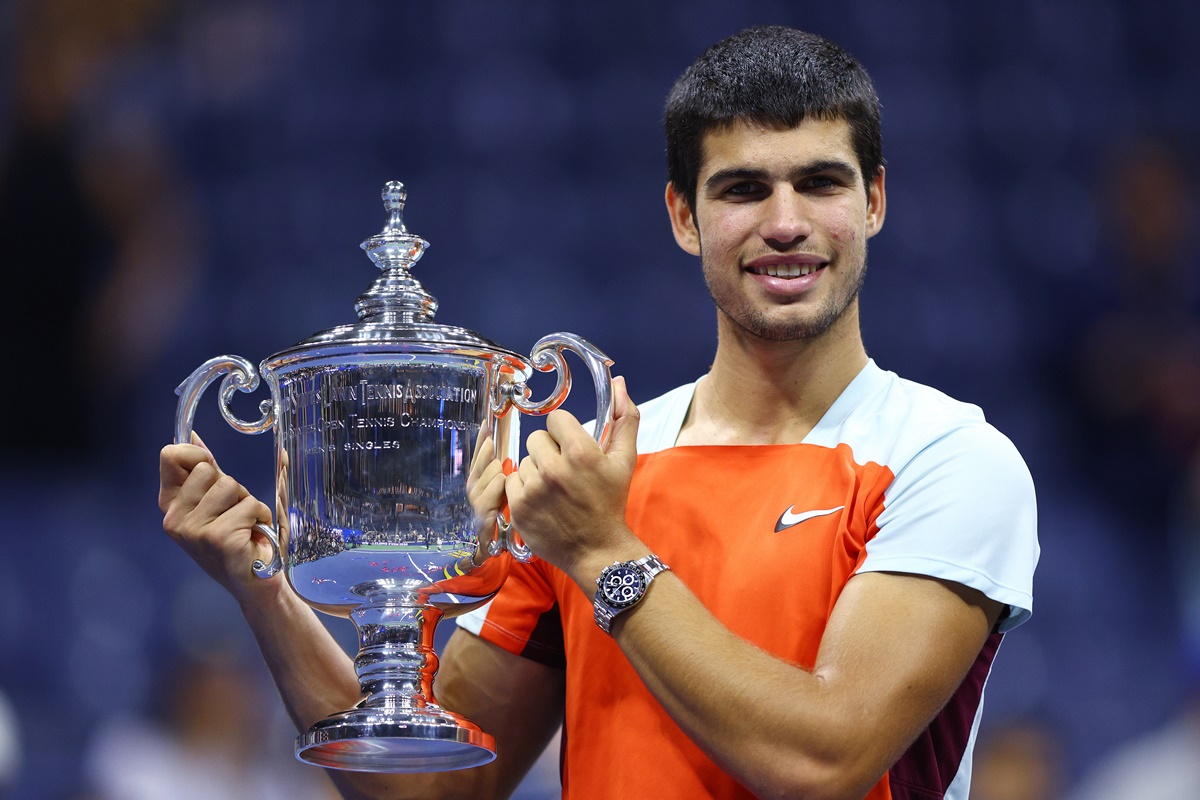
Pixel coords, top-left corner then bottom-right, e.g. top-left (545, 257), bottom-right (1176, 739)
top-left (354, 181), bottom-right (438, 323)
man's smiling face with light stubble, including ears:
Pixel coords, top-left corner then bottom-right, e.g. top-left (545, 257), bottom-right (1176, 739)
top-left (667, 119), bottom-right (884, 341)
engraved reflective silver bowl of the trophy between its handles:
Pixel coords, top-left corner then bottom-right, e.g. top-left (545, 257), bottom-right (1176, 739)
top-left (278, 356), bottom-right (487, 607)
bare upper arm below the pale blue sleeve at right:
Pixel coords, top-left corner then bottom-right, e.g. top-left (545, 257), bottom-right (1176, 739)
top-left (814, 572), bottom-right (1002, 780)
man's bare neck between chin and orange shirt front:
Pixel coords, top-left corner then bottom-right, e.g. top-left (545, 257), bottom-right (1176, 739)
top-left (677, 313), bottom-right (868, 445)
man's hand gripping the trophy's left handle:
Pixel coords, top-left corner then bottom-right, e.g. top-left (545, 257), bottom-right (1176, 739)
top-left (158, 434), bottom-right (281, 602)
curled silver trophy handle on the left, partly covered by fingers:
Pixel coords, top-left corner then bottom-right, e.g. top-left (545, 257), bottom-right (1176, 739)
top-left (175, 355), bottom-right (283, 578)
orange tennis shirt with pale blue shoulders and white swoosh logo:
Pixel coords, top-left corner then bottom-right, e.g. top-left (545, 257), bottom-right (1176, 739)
top-left (460, 361), bottom-right (1039, 800)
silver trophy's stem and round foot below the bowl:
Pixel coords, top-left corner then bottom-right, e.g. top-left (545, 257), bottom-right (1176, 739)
top-left (296, 595), bottom-right (496, 772)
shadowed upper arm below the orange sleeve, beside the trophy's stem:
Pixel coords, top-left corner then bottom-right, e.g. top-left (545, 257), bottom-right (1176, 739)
top-left (434, 628), bottom-right (565, 798)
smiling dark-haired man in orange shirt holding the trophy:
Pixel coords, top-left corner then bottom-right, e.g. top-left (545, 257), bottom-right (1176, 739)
top-left (161, 28), bottom-right (1038, 799)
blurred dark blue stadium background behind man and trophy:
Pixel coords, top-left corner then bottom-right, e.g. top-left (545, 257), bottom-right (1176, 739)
top-left (0, 0), bottom-right (1200, 800)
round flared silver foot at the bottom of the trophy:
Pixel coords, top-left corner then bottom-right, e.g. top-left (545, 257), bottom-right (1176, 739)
top-left (296, 709), bottom-right (496, 772)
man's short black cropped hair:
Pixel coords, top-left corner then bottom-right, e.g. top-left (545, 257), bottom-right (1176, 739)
top-left (665, 25), bottom-right (883, 207)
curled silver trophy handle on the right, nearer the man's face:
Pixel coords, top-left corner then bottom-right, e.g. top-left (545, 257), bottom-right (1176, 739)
top-left (497, 333), bottom-right (612, 561)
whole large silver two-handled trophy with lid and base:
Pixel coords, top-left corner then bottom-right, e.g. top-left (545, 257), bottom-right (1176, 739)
top-left (175, 181), bottom-right (612, 772)
